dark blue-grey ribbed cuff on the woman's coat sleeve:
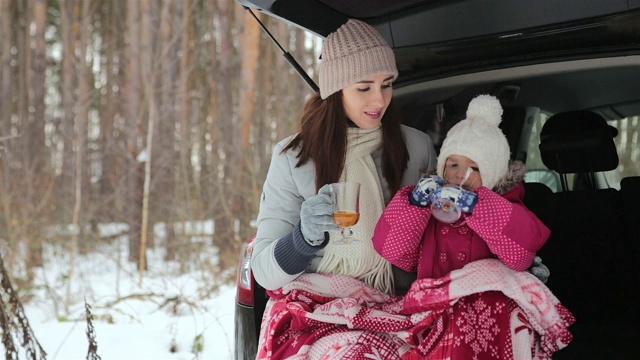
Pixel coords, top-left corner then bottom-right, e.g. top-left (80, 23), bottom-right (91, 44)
top-left (273, 223), bottom-right (328, 275)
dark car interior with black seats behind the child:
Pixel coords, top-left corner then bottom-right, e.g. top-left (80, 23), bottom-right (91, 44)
top-left (394, 57), bottom-right (640, 359)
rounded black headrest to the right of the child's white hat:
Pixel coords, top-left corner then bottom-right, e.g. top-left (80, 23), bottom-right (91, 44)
top-left (540, 110), bottom-right (618, 174)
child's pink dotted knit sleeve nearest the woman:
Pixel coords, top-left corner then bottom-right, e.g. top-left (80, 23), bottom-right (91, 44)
top-left (373, 185), bottom-right (431, 272)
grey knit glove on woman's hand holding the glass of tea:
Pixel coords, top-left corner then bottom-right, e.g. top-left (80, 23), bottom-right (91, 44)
top-left (300, 185), bottom-right (340, 246)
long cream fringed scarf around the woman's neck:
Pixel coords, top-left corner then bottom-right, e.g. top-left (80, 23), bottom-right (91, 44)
top-left (318, 127), bottom-right (393, 294)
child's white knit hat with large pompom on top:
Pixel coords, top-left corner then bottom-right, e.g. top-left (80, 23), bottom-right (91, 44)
top-left (437, 95), bottom-right (511, 189)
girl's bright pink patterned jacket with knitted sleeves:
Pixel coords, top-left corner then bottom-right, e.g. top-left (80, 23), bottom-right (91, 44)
top-left (373, 182), bottom-right (550, 279)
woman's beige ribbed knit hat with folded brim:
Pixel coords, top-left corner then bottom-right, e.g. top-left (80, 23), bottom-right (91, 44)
top-left (320, 19), bottom-right (398, 99)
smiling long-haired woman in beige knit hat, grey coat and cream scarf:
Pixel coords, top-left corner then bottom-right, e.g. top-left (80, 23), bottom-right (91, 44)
top-left (251, 20), bottom-right (436, 293)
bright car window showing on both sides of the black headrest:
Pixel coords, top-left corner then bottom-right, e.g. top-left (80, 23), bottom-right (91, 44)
top-left (525, 112), bottom-right (640, 192)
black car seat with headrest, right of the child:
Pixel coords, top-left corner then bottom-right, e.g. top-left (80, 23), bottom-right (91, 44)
top-left (525, 111), bottom-right (640, 359)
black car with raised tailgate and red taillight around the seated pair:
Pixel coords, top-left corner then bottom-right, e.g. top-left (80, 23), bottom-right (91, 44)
top-left (236, 0), bottom-right (640, 359)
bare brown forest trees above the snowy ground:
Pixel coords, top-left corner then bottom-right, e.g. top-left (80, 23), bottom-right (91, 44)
top-left (0, 0), bottom-right (320, 298)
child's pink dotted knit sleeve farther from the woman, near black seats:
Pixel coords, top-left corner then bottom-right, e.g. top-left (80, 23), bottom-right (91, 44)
top-left (466, 186), bottom-right (550, 270)
